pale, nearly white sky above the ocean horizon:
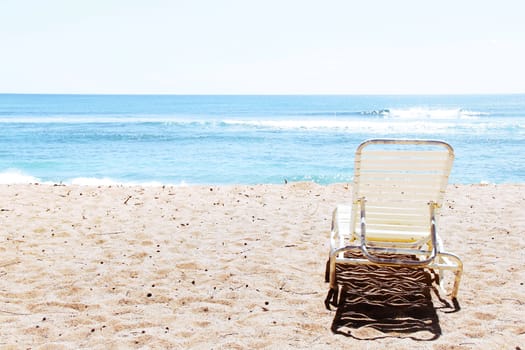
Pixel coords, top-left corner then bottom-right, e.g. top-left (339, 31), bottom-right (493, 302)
top-left (0, 0), bottom-right (525, 94)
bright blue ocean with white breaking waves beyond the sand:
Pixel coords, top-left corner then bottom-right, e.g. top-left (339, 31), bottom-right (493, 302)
top-left (0, 94), bottom-right (525, 185)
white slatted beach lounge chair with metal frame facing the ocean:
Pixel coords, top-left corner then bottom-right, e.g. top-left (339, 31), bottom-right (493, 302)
top-left (325, 139), bottom-right (463, 308)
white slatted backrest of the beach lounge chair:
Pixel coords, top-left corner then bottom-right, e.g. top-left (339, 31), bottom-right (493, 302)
top-left (351, 140), bottom-right (454, 245)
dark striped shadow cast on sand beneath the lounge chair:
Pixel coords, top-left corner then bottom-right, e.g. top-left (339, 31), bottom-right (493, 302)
top-left (325, 253), bottom-right (459, 341)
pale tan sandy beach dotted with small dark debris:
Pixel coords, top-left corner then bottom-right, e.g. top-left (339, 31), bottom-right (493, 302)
top-left (0, 183), bottom-right (525, 350)
